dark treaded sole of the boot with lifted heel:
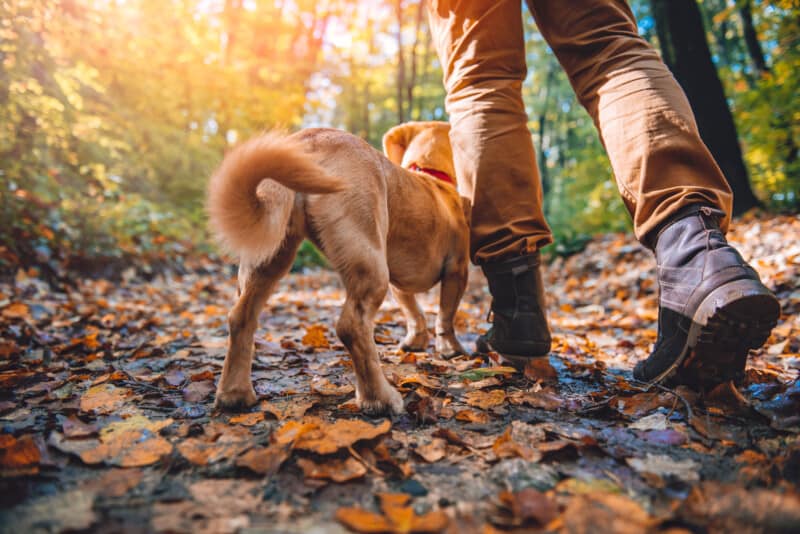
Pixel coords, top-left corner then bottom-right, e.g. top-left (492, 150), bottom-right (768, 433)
top-left (649, 280), bottom-right (780, 390)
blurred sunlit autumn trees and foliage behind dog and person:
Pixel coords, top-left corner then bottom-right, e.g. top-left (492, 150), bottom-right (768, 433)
top-left (0, 0), bottom-right (800, 277)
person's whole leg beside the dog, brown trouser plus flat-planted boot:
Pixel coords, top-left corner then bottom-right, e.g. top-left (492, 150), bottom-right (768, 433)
top-left (428, 0), bottom-right (552, 364)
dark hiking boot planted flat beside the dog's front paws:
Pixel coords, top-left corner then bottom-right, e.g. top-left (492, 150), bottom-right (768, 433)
top-left (475, 252), bottom-right (550, 368)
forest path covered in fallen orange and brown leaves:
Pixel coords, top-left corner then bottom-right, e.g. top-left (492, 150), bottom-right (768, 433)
top-left (0, 217), bottom-right (800, 532)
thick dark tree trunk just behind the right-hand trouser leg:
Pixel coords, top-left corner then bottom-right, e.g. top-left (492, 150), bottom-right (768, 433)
top-left (650, 0), bottom-right (759, 215)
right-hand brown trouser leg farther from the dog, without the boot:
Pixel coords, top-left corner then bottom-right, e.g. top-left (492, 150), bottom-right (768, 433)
top-left (528, 0), bottom-right (732, 241)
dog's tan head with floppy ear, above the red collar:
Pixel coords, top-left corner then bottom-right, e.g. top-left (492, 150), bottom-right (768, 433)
top-left (383, 121), bottom-right (456, 186)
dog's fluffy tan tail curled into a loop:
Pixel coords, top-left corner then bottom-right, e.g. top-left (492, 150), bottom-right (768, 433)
top-left (207, 133), bottom-right (345, 264)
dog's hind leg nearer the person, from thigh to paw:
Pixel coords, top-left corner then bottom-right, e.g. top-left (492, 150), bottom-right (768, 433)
top-left (336, 258), bottom-right (403, 414)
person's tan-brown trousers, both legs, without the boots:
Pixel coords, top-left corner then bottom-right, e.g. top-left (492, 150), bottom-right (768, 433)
top-left (428, 0), bottom-right (732, 264)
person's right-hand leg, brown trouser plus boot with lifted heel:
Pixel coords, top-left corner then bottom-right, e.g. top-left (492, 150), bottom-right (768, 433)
top-left (527, 0), bottom-right (780, 386)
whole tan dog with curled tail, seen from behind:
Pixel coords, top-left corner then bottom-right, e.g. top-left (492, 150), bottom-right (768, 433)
top-left (208, 122), bottom-right (468, 413)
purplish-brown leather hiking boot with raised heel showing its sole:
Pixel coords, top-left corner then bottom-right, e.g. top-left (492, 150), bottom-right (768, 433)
top-left (633, 205), bottom-right (780, 389)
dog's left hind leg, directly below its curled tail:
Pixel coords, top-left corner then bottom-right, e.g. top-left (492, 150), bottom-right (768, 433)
top-left (214, 236), bottom-right (302, 409)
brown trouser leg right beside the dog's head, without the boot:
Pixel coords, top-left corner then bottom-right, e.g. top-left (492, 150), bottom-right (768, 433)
top-left (428, 0), bottom-right (552, 265)
